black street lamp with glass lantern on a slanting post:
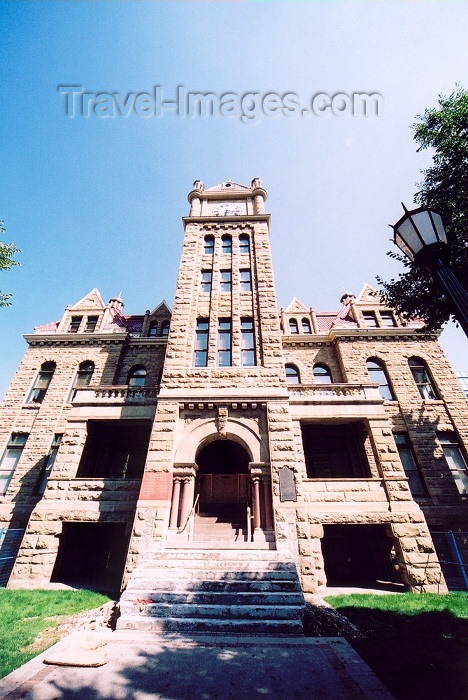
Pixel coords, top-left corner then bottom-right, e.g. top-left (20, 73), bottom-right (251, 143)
top-left (392, 204), bottom-right (468, 336)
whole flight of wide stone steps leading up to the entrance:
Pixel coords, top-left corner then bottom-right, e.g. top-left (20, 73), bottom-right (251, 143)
top-left (117, 547), bottom-right (304, 636)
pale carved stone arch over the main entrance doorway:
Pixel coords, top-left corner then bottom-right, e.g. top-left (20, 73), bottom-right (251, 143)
top-left (174, 418), bottom-right (265, 464)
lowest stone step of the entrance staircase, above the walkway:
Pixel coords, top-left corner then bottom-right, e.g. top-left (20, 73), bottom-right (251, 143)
top-left (117, 615), bottom-right (304, 637)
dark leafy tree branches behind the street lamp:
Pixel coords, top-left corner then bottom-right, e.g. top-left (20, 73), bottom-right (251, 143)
top-left (377, 86), bottom-right (468, 330)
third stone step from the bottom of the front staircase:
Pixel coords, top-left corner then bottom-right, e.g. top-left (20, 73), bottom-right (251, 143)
top-left (121, 589), bottom-right (304, 606)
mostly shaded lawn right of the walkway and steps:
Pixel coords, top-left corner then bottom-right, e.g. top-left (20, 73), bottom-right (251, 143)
top-left (325, 593), bottom-right (468, 700)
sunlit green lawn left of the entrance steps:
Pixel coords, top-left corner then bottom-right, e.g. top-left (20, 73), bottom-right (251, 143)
top-left (0, 589), bottom-right (109, 678)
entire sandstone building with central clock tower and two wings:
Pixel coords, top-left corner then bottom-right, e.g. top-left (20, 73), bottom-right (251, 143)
top-left (0, 179), bottom-right (468, 592)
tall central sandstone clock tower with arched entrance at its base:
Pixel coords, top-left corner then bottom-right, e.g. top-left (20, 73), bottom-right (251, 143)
top-left (140, 179), bottom-right (301, 556)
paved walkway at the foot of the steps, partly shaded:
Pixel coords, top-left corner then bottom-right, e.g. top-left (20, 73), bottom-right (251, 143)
top-left (0, 630), bottom-right (394, 700)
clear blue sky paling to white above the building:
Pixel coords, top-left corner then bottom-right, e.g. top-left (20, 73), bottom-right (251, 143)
top-left (0, 0), bottom-right (468, 395)
